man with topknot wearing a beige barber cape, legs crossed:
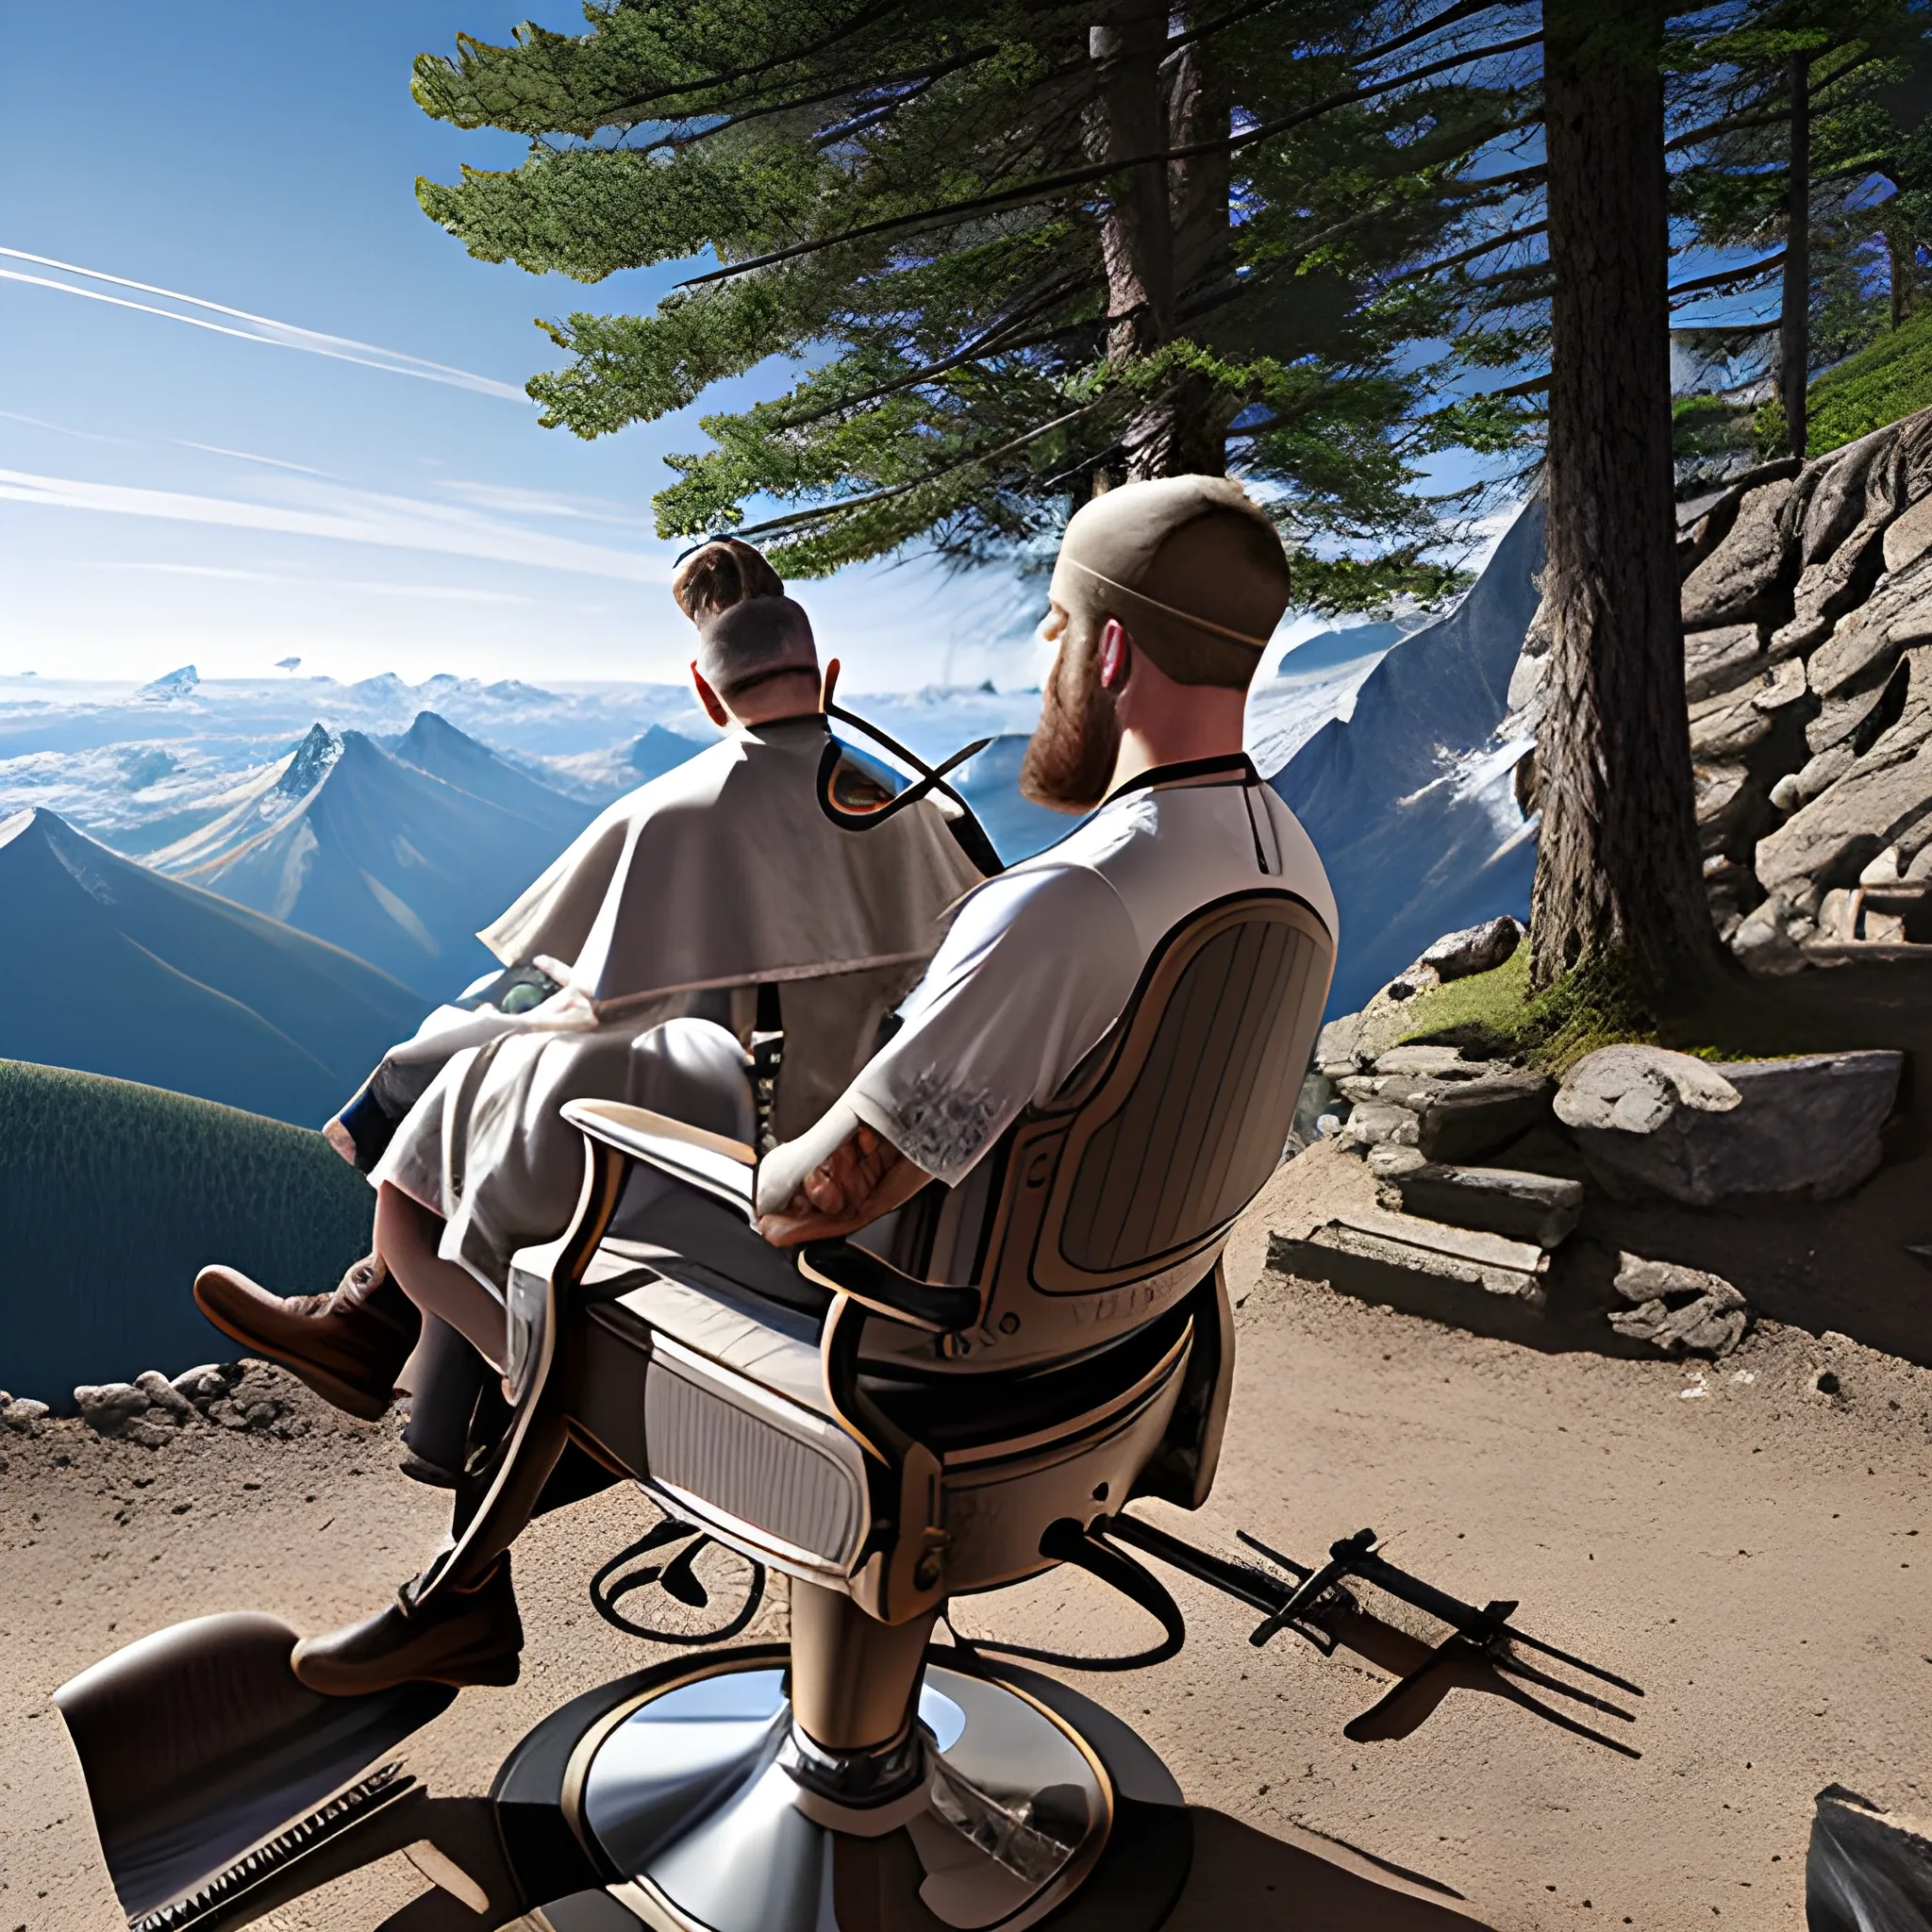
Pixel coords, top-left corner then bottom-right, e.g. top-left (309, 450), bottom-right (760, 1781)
top-left (195, 542), bottom-right (981, 1480)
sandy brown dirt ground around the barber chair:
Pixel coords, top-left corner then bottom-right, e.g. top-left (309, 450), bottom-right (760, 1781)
top-left (0, 1169), bottom-right (1932, 1932)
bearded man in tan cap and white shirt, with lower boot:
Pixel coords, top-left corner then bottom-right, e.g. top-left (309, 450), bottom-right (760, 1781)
top-left (293, 477), bottom-right (1335, 1694)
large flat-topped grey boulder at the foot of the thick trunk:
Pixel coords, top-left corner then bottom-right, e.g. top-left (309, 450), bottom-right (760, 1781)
top-left (1553, 1047), bottom-right (1905, 1208)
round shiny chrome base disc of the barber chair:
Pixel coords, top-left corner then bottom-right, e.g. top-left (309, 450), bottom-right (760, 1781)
top-left (494, 1646), bottom-right (1192, 1932)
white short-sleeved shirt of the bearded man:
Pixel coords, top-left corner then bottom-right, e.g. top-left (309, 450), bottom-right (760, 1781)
top-left (846, 763), bottom-right (1337, 1186)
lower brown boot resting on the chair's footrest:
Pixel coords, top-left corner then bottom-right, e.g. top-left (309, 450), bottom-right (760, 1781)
top-left (290, 1556), bottom-right (524, 1696)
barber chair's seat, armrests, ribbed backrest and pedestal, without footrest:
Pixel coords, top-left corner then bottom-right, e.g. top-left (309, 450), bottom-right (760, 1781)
top-left (452, 892), bottom-right (1331, 1932)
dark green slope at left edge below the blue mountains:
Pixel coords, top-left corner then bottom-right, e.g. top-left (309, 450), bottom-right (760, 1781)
top-left (0, 1060), bottom-right (375, 1407)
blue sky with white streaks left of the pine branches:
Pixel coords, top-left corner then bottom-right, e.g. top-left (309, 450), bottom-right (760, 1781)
top-left (0, 0), bottom-right (1038, 688)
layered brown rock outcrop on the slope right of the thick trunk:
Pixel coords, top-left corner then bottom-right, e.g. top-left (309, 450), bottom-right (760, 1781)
top-left (1499, 411), bottom-right (1932, 974)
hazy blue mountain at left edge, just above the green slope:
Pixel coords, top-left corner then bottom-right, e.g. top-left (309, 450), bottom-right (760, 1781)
top-left (0, 811), bottom-right (425, 1126)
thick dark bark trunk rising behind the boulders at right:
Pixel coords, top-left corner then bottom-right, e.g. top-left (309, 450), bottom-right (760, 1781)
top-left (1530, 0), bottom-right (1716, 988)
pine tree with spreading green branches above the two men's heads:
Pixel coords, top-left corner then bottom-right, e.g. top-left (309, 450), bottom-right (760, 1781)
top-left (415, 0), bottom-right (1534, 608)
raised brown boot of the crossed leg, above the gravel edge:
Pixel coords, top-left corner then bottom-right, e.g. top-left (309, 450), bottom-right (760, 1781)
top-left (195, 1254), bottom-right (424, 1422)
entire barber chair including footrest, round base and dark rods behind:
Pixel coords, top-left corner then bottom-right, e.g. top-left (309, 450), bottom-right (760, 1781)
top-left (56, 891), bottom-right (1635, 1932)
